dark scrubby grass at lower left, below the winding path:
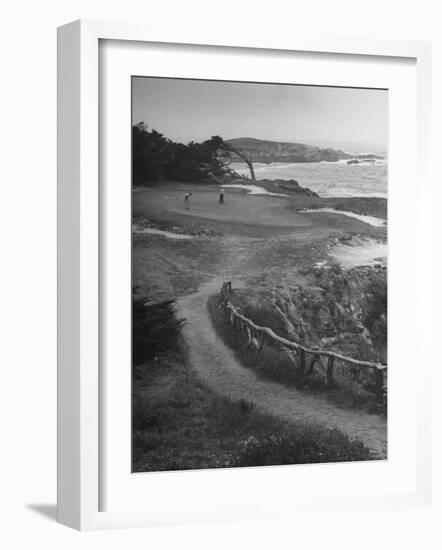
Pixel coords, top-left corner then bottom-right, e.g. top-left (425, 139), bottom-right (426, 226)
top-left (132, 302), bottom-right (376, 472)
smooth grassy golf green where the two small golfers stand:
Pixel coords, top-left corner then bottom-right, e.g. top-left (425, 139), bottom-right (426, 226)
top-left (133, 182), bottom-right (386, 238)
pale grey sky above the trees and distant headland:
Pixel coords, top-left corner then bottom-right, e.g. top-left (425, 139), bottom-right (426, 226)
top-left (132, 77), bottom-right (388, 152)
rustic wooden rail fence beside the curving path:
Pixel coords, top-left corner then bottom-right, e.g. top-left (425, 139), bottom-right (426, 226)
top-left (221, 281), bottom-right (387, 403)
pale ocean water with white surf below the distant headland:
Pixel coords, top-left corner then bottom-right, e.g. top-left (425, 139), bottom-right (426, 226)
top-left (230, 160), bottom-right (388, 198)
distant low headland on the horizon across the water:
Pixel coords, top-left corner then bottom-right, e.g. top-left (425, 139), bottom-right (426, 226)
top-left (227, 138), bottom-right (354, 163)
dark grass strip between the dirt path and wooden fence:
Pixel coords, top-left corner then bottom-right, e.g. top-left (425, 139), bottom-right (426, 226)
top-left (207, 295), bottom-right (385, 414)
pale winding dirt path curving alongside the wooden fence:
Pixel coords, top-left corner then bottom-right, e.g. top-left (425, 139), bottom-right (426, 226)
top-left (177, 276), bottom-right (387, 458)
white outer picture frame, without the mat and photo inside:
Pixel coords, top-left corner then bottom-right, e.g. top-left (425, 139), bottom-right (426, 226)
top-left (58, 21), bottom-right (432, 530)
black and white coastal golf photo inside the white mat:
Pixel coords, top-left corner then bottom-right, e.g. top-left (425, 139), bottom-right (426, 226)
top-left (128, 75), bottom-right (388, 472)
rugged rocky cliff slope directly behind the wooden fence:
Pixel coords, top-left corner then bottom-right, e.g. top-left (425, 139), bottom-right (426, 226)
top-left (231, 264), bottom-right (387, 368)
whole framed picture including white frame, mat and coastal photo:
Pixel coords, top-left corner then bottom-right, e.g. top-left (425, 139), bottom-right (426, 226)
top-left (58, 21), bottom-right (432, 530)
